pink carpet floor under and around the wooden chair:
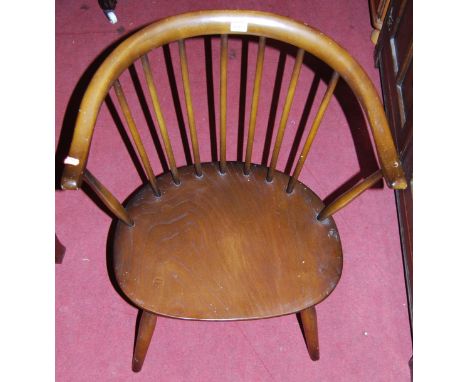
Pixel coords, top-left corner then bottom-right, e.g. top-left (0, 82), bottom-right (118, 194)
top-left (56, 0), bottom-right (412, 382)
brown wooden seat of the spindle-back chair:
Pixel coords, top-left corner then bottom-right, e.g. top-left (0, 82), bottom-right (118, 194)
top-left (113, 162), bottom-right (343, 320)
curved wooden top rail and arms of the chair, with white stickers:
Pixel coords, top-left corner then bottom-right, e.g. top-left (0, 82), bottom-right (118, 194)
top-left (62, 10), bottom-right (406, 189)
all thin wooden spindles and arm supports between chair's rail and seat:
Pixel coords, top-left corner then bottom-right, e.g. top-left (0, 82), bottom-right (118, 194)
top-left (78, 35), bottom-right (383, 226)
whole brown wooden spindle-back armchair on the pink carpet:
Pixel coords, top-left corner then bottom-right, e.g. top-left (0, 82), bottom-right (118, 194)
top-left (62, 11), bottom-right (406, 371)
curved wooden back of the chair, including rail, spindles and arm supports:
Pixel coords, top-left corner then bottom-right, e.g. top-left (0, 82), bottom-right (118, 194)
top-left (62, 10), bottom-right (406, 224)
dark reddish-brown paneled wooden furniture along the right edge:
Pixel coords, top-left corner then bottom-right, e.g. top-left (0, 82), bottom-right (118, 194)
top-left (375, 0), bottom-right (413, 321)
